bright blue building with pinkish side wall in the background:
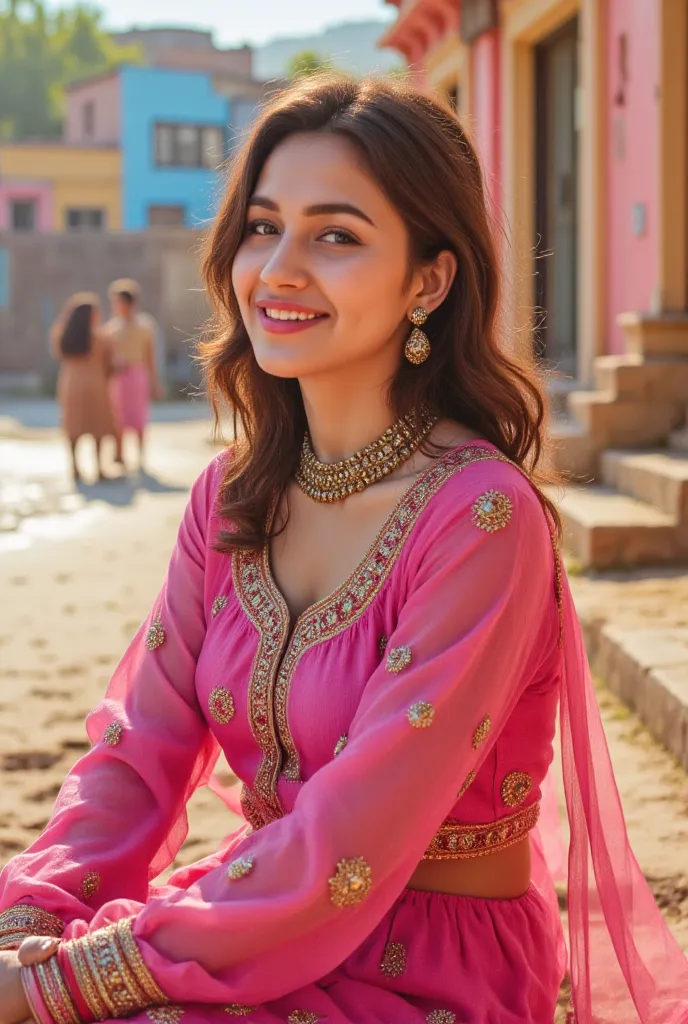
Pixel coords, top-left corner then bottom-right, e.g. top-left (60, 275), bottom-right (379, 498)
top-left (66, 67), bottom-right (259, 230)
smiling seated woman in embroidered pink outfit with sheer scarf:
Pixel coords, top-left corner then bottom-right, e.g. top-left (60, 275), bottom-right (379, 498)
top-left (0, 79), bottom-right (688, 1024)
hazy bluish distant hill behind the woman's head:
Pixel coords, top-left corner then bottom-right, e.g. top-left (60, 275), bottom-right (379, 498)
top-left (253, 22), bottom-right (402, 79)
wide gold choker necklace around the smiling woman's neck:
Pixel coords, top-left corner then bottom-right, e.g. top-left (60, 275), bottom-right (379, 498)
top-left (296, 414), bottom-right (437, 503)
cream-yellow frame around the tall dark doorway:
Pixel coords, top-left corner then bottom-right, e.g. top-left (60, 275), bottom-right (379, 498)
top-left (502, 0), bottom-right (602, 383)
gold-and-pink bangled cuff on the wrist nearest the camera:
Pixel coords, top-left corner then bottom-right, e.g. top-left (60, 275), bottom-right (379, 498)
top-left (25, 918), bottom-right (170, 1024)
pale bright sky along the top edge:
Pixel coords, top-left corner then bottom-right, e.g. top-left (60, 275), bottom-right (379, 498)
top-left (82, 0), bottom-right (395, 46)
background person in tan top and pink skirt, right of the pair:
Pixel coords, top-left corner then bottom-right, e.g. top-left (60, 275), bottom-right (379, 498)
top-left (104, 279), bottom-right (162, 468)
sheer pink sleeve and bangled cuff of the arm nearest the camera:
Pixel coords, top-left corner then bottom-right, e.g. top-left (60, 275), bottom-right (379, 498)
top-left (22, 466), bottom-right (558, 1021)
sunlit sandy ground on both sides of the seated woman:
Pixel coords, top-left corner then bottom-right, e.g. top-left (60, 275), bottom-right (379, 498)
top-left (0, 422), bottom-right (688, 999)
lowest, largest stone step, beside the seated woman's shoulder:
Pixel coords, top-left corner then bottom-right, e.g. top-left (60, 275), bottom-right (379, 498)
top-left (552, 484), bottom-right (688, 569)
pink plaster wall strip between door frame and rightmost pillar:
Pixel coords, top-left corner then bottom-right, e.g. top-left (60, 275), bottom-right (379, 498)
top-left (605, 0), bottom-right (659, 352)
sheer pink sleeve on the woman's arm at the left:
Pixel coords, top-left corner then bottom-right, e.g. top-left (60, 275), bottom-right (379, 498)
top-left (0, 463), bottom-right (223, 948)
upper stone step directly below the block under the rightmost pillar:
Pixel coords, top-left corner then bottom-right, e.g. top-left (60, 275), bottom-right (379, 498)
top-left (595, 355), bottom-right (688, 402)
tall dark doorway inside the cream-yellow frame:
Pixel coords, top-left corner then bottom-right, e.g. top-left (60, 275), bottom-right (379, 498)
top-left (534, 17), bottom-right (578, 377)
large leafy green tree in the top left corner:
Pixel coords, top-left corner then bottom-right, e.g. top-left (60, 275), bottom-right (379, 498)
top-left (0, 0), bottom-right (140, 139)
